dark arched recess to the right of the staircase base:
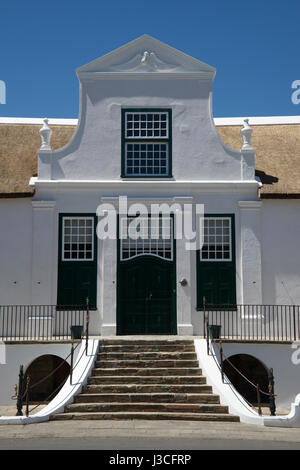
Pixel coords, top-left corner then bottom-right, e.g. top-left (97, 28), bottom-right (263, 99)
top-left (223, 354), bottom-right (269, 405)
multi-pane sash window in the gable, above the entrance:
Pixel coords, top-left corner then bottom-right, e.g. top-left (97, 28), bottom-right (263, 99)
top-left (122, 109), bottom-right (171, 177)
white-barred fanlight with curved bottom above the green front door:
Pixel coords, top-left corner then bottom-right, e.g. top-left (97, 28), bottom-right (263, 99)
top-left (120, 217), bottom-right (173, 261)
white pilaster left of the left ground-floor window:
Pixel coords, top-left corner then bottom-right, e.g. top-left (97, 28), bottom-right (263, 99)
top-left (31, 201), bottom-right (58, 305)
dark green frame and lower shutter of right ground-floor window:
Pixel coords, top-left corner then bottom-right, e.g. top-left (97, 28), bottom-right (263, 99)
top-left (197, 214), bottom-right (236, 309)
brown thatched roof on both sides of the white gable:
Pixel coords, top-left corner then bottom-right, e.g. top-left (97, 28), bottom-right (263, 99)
top-left (0, 118), bottom-right (300, 198)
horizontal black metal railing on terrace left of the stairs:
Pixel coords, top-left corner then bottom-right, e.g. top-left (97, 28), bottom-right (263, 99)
top-left (0, 302), bottom-right (89, 341)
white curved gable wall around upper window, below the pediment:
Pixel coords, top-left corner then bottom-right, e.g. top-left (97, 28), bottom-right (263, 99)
top-left (38, 79), bottom-right (254, 181)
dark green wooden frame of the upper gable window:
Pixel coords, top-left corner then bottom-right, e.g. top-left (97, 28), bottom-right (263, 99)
top-left (121, 108), bottom-right (172, 178)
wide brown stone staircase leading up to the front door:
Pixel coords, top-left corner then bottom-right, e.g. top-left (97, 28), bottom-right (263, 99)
top-left (51, 338), bottom-right (239, 422)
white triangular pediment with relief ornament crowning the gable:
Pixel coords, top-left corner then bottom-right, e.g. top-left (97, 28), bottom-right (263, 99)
top-left (77, 35), bottom-right (215, 78)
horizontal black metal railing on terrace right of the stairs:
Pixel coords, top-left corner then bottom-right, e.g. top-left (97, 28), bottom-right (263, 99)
top-left (202, 302), bottom-right (300, 342)
